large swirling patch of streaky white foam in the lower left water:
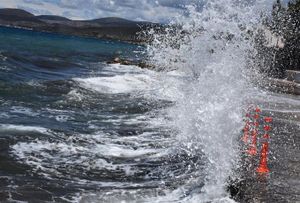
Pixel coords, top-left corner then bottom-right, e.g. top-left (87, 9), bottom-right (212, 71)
top-left (11, 128), bottom-right (170, 186)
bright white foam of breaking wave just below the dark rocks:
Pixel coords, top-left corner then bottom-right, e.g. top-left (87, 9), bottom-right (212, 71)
top-left (73, 64), bottom-right (184, 101)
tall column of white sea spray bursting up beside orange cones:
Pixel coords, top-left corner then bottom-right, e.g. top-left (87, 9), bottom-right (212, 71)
top-left (148, 0), bottom-right (270, 202)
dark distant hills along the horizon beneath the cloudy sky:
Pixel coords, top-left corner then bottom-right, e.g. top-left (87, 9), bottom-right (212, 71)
top-left (0, 8), bottom-right (159, 42)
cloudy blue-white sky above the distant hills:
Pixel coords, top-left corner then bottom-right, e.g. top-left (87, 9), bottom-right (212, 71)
top-left (0, 0), bottom-right (288, 22)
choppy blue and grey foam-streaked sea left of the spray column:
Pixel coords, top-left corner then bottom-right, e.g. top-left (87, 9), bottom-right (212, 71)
top-left (0, 27), bottom-right (180, 202)
